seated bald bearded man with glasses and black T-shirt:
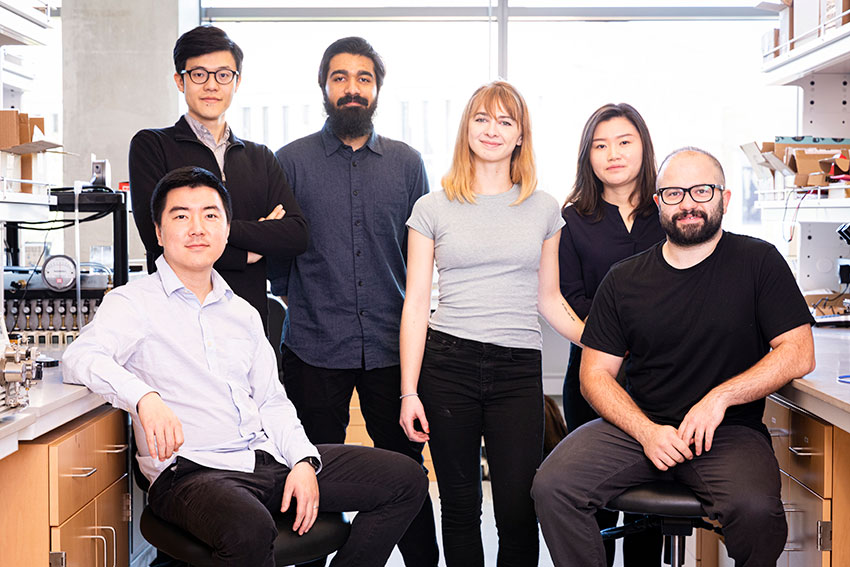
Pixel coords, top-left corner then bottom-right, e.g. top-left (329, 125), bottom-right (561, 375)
top-left (532, 148), bottom-right (814, 567)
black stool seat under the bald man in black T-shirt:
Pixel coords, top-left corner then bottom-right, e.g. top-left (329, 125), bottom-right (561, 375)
top-left (606, 481), bottom-right (706, 518)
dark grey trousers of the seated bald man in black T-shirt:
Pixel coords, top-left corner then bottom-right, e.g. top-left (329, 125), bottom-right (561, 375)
top-left (532, 419), bottom-right (787, 567)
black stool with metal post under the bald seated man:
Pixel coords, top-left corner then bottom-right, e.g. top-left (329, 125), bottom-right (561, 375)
top-left (601, 482), bottom-right (722, 567)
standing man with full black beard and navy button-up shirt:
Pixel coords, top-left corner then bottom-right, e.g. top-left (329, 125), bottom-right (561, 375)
top-left (269, 37), bottom-right (439, 567)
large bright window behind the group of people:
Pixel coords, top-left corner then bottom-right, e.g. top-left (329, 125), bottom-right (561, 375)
top-left (203, 4), bottom-right (798, 234)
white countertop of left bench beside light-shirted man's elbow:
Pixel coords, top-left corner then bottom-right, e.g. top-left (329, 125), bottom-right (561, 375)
top-left (0, 360), bottom-right (105, 459)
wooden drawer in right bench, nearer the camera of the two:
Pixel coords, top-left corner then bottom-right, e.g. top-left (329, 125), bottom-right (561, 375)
top-left (787, 409), bottom-right (832, 498)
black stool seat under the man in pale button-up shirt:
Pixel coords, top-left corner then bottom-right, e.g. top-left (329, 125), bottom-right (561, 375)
top-left (139, 507), bottom-right (351, 567)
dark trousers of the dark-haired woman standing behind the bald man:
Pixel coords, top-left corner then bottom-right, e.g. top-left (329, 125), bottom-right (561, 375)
top-left (564, 344), bottom-right (664, 567)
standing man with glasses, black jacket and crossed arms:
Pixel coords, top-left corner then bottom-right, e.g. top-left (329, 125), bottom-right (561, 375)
top-left (130, 26), bottom-right (308, 330)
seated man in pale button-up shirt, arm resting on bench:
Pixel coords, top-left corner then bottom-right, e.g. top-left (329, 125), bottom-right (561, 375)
top-left (63, 167), bottom-right (428, 567)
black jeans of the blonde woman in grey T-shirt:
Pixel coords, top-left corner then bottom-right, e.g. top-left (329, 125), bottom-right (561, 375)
top-left (419, 330), bottom-right (543, 567)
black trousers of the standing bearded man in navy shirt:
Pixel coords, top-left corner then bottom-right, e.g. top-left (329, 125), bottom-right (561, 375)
top-left (283, 346), bottom-right (440, 567)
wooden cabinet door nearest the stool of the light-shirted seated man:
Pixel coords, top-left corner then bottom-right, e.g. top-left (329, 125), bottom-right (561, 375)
top-left (95, 475), bottom-right (130, 567)
